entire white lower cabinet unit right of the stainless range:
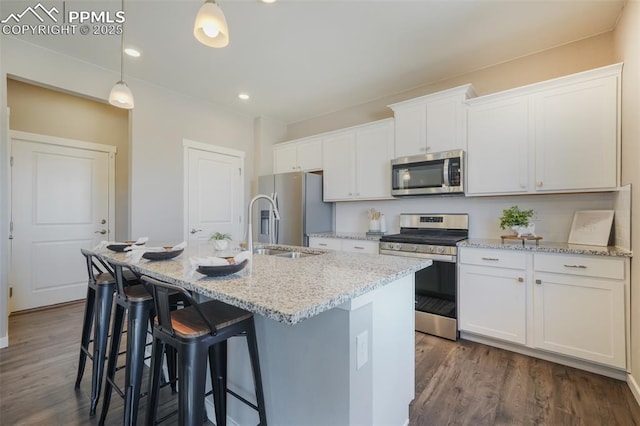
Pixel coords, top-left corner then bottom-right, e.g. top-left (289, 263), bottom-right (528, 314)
top-left (458, 247), bottom-right (629, 369)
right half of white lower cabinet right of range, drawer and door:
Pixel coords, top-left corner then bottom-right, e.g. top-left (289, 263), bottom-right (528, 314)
top-left (533, 254), bottom-right (626, 368)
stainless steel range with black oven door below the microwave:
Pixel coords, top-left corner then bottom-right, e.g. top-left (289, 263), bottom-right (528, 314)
top-left (380, 214), bottom-right (469, 340)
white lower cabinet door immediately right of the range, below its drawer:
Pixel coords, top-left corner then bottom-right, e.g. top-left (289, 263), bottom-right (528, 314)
top-left (458, 265), bottom-right (526, 344)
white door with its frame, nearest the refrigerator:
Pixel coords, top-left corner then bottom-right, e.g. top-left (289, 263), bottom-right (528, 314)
top-left (184, 141), bottom-right (244, 242)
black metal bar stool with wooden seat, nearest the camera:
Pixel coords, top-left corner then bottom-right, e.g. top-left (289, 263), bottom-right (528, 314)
top-left (142, 276), bottom-right (267, 426)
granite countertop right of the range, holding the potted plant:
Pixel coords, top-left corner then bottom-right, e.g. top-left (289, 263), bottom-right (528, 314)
top-left (458, 238), bottom-right (632, 257)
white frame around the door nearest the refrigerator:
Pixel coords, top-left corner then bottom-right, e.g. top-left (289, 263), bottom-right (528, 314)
top-left (182, 139), bottom-right (246, 241)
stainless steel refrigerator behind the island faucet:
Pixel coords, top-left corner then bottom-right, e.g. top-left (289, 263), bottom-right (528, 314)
top-left (253, 172), bottom-right (333, 247)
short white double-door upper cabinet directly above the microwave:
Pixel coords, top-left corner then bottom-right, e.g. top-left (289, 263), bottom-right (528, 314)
top-left (389, 84), bottom-right (475, 157)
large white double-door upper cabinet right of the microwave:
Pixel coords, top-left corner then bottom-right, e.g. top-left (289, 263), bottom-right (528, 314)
top-left (467, 64), bottom-right (622, 195)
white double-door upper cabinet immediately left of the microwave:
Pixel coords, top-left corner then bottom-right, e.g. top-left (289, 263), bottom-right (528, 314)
top-left (323, 119), bottom-right (393, 201)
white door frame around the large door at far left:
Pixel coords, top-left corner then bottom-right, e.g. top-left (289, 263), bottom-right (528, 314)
top-left (7, 130), bottom-right (117, 312)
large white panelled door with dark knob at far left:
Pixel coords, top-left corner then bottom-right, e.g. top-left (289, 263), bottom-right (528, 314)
top-left (9, 132), bottom-right (115, 311)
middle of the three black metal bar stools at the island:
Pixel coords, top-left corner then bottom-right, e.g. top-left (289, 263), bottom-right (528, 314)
top-left (99, 260), bottom-right (153, 425)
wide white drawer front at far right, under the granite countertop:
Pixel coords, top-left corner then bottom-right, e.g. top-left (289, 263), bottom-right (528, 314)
top-left (533, 254), bottom-right (625, 280)
